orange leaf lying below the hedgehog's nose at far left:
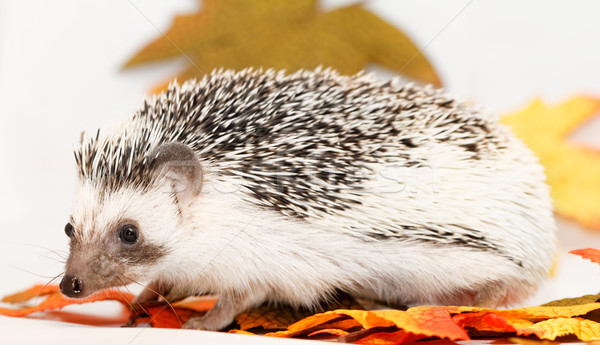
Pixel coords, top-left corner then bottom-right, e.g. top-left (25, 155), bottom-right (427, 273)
top-left (0, 287), bottom-right (134, 316)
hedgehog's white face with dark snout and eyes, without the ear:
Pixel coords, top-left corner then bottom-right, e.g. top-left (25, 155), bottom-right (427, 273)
top-left (61, 183), bottom-right (180, 298)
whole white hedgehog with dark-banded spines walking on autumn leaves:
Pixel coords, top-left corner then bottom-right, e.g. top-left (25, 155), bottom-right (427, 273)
top-left (61, 69), bottom-right (556, 330)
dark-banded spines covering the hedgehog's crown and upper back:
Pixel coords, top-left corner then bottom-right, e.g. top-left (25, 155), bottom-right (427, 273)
top-left (76, 68), bottom-right (504, 222)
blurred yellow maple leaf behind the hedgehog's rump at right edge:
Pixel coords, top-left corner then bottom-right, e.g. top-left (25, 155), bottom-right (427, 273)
top-left (501, 97), bottom-right (600, 229)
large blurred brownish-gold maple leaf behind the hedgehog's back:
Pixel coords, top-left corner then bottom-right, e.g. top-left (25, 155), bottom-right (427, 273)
top-left (125, 0), bottom-right (440, 89)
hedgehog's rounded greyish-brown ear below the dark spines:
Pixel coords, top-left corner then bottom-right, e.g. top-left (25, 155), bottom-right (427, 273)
top-left (150, 143), bottom-right (204, 205)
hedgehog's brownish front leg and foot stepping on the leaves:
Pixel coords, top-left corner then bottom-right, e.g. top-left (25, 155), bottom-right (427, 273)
top-left (183, 291), bottom-right (266, 331)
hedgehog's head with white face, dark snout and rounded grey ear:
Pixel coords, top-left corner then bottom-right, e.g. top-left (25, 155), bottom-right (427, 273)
top-left (60, 144), bottom-right (202, 298)
